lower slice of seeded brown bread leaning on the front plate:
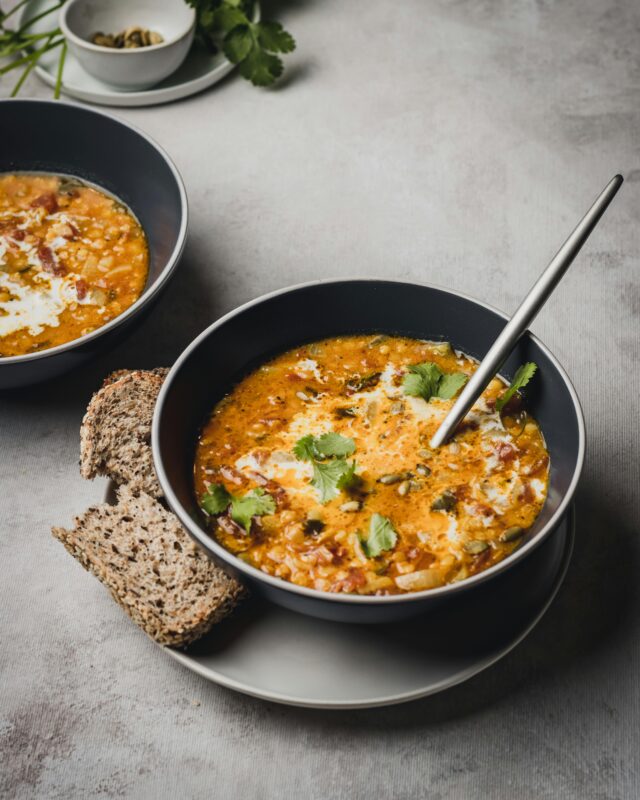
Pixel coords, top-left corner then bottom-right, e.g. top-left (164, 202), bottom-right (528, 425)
top-left (52, 487), bottom-right (244, 646)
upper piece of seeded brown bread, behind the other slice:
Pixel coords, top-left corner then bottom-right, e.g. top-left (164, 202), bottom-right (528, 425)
top-left (80, 368), bottom-right (168, 497)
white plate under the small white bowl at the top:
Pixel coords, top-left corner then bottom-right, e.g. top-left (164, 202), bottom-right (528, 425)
top-left (22, 0), bottom-right (260, 108)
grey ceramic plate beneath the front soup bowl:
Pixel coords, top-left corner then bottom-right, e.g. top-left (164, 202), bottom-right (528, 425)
top-left (164, 508), bottom-right (574, 708)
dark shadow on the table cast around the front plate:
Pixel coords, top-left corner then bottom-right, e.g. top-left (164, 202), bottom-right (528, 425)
top-left (229, 476), bottom-right (638, 730)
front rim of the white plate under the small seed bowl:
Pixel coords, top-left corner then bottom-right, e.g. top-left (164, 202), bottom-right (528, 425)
top-left (20, 0), bottom-right (262, 108)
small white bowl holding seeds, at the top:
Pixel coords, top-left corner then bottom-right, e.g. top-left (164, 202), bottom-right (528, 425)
top-left (60, 0), bottom-right (196, 91)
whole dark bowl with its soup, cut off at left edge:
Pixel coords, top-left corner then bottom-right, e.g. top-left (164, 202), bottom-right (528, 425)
top-left (0, 100), bottom-right (187, 389)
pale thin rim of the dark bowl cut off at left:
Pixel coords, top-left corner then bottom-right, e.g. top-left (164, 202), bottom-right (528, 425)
top-left (0, 98), bottom-right (189, 369)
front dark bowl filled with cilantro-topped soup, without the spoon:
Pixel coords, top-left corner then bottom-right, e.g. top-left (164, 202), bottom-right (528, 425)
top-left (153, 279), bottom-right (584, 622)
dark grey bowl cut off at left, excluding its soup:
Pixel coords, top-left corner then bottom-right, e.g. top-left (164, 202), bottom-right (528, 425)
top-left (0, 100), bottom-right (187, 389)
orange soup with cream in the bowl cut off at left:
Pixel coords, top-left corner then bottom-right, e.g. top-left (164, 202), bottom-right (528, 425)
top-left (0, 173), bottom-right (149, 357)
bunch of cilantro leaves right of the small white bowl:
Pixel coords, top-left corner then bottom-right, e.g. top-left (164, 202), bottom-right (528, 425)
top-left (186, 0), bottom-right (296, 86)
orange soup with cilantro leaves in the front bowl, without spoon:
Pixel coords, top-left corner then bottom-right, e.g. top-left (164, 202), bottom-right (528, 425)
top-left (195, 336), bottom-right (549, 594)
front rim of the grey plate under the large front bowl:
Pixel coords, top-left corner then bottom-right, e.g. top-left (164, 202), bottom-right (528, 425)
top-left (157, 510), bottom-right (576, 711)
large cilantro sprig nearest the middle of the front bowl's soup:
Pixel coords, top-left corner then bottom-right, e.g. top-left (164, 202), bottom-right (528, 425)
top-left (293, 432), bottom-right (358, 503)
